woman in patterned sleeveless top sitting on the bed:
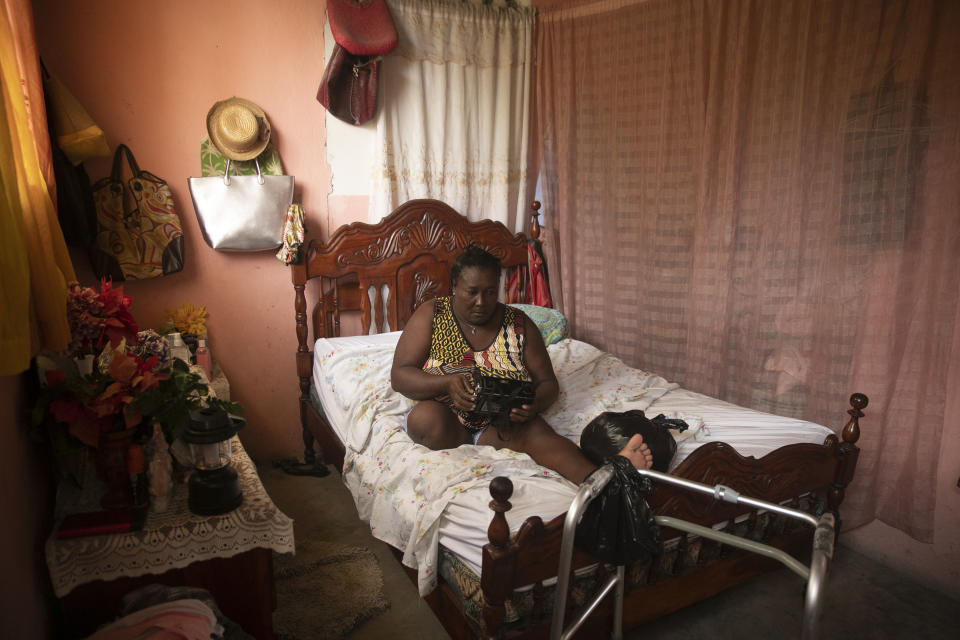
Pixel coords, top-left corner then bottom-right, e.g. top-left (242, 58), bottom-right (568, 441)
top-left (390, 245), bottom-right (652, 484)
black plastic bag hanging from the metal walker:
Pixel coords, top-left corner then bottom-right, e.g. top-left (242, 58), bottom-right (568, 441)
top-left (575, 455), bottom-right (663, 565)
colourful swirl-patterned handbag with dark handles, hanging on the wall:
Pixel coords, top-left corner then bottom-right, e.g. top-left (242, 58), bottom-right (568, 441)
top-left (91, 144), bottom-right (184, 282)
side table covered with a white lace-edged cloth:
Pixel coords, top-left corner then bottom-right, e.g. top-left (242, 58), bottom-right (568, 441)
top-left (45, 436), bottom-right (294, 640)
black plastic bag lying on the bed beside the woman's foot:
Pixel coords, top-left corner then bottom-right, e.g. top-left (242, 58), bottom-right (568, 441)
top-left (580, 409), bottom-right (687, 473)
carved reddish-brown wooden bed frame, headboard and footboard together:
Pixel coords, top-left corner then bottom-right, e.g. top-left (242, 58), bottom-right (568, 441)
top-left (292, 200), bottom-right (867, 638)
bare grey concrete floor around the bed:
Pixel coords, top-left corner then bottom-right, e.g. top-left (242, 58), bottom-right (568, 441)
top-left (258, 465), bottom-right (960, 640)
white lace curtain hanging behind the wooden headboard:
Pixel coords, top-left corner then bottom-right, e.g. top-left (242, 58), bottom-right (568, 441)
top-left (370, 0), bottom-right (534, 231)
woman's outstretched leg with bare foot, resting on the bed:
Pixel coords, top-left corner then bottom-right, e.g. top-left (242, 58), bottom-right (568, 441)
top-left (477, 416), bottom-right (653, 484)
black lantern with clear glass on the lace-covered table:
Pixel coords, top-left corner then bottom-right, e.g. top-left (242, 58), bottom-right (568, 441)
top-left (183, 408), bottom-right (246, 516)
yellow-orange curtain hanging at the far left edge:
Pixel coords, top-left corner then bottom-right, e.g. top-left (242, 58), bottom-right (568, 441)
top-left (0, 0), bottom-right (76, 375)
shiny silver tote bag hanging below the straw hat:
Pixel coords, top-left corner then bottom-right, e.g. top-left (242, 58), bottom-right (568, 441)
top-left (187, 159), bottom-right (293, 251)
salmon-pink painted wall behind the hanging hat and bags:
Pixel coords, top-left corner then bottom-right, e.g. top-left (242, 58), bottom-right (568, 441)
top-left (33, 0), bottom-right (346, 459)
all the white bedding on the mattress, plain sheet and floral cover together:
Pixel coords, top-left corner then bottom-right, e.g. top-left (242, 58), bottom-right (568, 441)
top-left (313, 332), bottom-right (833, 595)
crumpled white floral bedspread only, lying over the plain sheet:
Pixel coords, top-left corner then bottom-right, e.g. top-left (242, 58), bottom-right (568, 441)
top-left (320, 339), bottom-right (677, 595)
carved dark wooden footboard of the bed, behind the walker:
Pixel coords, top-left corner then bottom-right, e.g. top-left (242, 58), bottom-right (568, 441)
top-left (480, 393), bottom-right (868, 638)
